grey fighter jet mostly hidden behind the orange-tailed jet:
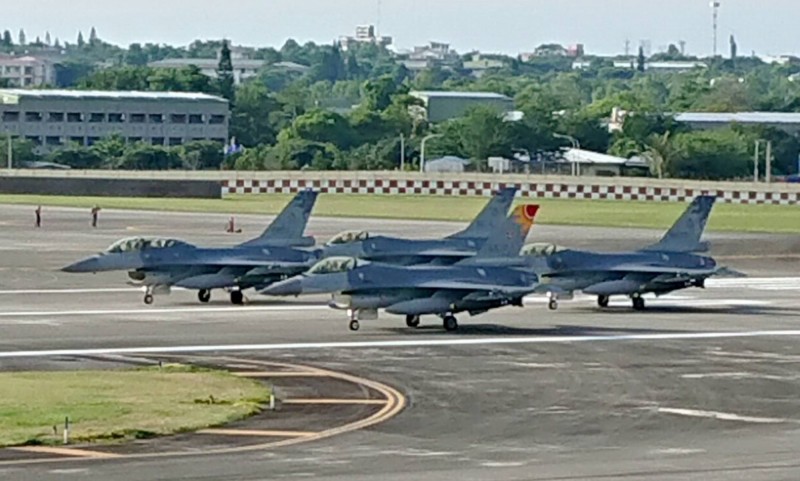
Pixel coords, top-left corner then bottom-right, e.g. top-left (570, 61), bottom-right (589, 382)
top-left (322, 187), bottom-right (517, 265)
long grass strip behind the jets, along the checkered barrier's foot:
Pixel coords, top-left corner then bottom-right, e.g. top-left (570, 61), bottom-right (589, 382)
top-left (0, 194), bottom-right (800, 233)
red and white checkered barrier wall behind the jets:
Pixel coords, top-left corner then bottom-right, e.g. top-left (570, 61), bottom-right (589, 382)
top-left (222, 178), bottom-right (800, 205)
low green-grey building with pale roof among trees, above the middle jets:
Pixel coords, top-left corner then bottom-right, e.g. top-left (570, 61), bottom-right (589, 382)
top-left (410, 91), bottom-right (514, 122)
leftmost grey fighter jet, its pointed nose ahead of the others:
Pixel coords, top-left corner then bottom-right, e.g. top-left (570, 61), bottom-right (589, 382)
top-left (62, 191), bottom-right (319, 305)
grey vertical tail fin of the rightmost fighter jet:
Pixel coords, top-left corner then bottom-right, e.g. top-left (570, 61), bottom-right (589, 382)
top-left (642, 195), bottom-right (717, 252)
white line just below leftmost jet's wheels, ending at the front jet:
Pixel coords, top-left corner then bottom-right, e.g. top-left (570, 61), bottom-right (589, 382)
top-left (0, 305), bottom-right (330, 318)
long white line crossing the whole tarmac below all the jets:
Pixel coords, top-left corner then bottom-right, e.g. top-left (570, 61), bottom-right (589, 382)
top-left (0, 330), bottom-right (800, 359)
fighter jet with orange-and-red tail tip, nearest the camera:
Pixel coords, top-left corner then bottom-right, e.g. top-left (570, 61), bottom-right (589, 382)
top-left (261, 205), bottom-right (538, 331)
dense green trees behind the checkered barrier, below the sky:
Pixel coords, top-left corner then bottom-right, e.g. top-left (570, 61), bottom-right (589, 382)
top-left (4, 30), bottom-right (800, 179)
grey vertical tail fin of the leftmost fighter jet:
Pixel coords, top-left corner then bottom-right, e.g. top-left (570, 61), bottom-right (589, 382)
top-left (242, 190), bottom-right (317, 247)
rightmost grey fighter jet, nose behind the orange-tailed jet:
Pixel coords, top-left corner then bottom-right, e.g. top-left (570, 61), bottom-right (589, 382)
top-left (523, 196), bottom-right (741, 310)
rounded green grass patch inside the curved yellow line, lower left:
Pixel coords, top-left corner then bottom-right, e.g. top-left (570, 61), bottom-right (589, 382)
top-left (0, 365), bottom-right (270, 446)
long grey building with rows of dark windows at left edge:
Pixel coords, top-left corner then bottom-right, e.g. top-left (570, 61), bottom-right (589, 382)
top-left (0, 89), bottom-right (230, 153)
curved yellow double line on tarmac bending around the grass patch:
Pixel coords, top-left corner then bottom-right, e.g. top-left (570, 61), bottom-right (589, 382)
top-left (0, 356), bottom-right (406, 466)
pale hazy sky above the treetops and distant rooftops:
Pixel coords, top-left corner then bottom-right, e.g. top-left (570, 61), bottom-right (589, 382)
top-left (0, 0), bottom-right (800, 55)
